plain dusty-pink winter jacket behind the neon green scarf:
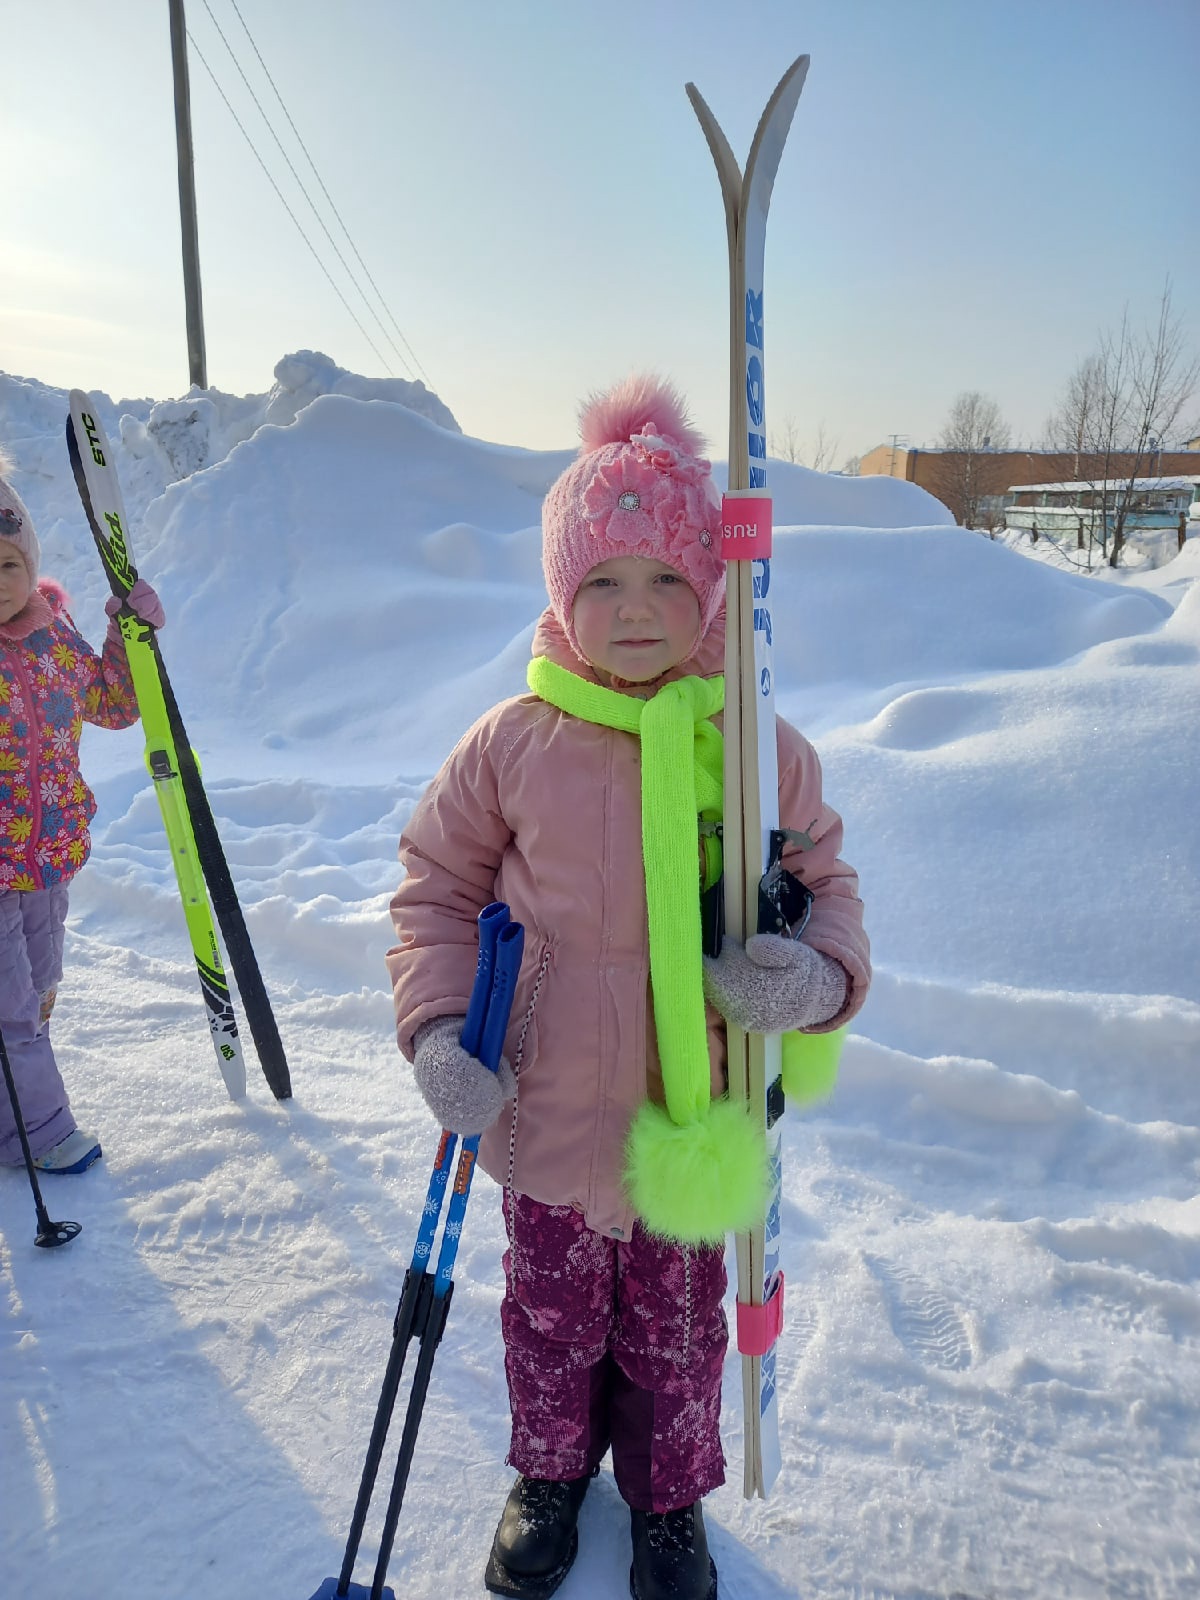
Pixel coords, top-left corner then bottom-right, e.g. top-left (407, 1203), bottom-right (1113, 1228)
top-left (395, 611), bottom-right (870, 1238)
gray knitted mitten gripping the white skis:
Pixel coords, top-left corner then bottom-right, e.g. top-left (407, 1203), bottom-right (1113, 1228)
top-left (704, 933), bottom-right (850, 1034)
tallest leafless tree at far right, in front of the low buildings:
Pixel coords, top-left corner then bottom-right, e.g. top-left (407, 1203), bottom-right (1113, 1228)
top-left (1046, 280), bottom-right (1200, 566)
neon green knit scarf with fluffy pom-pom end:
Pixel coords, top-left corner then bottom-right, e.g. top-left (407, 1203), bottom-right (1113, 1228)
top-left (526, 656), bottom-right (766, 1243)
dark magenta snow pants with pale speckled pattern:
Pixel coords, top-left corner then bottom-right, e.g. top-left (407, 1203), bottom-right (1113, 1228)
top-left (501, 1190), bottom-right (728, 1512)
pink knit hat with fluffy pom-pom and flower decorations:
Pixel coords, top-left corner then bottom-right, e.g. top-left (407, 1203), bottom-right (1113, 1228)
top-left (542, 376), bottom-right (725, 658)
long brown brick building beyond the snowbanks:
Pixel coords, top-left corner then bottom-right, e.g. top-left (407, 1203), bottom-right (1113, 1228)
top-left (859, 440), bottom-right (1200, 526)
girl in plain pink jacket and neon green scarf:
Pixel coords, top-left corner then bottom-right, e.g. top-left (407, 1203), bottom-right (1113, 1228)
top-left (387, 378), bottom-right (870, 1600)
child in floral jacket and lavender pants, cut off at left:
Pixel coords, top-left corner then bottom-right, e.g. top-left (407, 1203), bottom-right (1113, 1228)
top-left (0, 456), bottom-right (163, 1173)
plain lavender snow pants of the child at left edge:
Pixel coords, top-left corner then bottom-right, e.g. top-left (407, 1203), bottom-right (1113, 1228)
top-left (0, 886), bottom-right (75, 1166)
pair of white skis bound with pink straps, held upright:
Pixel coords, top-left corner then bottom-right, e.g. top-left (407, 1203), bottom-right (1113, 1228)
top-left (686, 56), bottom-right (808, 1498)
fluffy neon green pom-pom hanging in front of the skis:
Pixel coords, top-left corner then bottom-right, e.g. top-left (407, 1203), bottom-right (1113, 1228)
top-left (626, 1099), bottom-right (768, 1245)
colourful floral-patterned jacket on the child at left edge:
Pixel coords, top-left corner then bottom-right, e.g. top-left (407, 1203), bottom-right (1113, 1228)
top-left (0, 579), bottom-right (138, 891)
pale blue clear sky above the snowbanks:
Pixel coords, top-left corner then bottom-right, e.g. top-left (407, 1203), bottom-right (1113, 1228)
top-left (0, 0), bottom-right (1200, 464)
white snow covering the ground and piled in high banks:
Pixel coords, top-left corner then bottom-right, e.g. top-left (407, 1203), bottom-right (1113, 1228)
top-left (0, 363), bottom-right (1200, 1600)
